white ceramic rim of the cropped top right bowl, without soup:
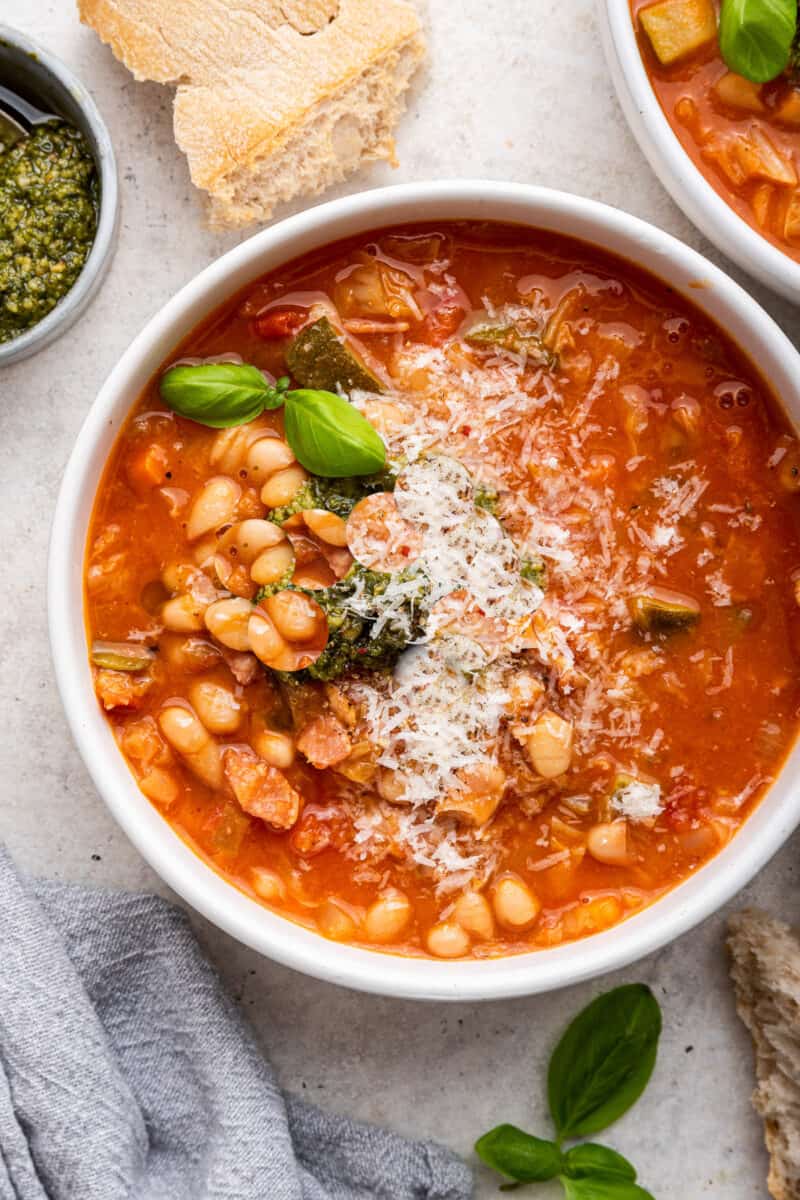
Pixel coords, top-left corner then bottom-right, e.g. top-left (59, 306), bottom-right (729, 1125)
top-left (600, 0), bottom-right (800, 301)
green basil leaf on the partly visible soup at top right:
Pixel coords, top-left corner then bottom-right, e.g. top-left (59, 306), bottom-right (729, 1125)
top-left (720, 0), bottom-right (798, 83)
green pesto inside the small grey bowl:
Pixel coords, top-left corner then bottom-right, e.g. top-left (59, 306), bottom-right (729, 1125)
top-left (0, 121), bottom-right (97, 342)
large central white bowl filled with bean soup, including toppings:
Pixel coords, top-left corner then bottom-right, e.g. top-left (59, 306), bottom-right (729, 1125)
top-left (50, 185), bottom-right (800, 997)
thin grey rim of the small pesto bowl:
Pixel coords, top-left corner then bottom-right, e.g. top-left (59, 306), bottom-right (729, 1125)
top-left (0, 24), bottom-right (120, 367)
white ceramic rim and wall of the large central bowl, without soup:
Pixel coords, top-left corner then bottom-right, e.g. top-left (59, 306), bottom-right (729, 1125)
top-left (48, 181), bottom-right (800, 1001)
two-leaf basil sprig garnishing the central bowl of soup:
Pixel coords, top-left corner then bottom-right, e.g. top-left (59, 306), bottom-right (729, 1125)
top-left (158, 362), bottom-right (386, 479)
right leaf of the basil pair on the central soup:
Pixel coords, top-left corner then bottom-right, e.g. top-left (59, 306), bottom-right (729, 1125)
top-left (283, 388), bottom-right (386, 479)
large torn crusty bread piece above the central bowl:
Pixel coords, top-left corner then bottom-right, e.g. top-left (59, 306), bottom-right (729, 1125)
top-left (78, 0), bottom-right (425, 228)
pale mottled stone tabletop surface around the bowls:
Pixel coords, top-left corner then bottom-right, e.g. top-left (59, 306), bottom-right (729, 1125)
top-left (0, 0), bottom-right (800, 1200)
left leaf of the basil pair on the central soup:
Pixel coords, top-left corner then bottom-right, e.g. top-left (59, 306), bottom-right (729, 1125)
top-left (158, 362), bottom-right (283, 430)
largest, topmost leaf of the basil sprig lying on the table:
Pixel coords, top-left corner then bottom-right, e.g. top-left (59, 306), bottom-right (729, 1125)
top-left (547, 984), bottom-right (661, 1138)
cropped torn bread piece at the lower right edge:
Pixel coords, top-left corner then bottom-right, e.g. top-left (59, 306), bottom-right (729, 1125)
top-left (728, 908), bottom-right (800, 1200)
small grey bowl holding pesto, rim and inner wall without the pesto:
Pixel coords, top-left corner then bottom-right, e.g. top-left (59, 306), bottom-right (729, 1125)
top-left (0, 25), bottom-right (119, 366)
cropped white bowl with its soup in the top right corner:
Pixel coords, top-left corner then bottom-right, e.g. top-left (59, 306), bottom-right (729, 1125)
top-left (601, 0), bottom-right (800, 300)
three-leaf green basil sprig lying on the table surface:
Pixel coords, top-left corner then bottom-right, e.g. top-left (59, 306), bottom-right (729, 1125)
top-left (475, 984), bottom-right (661, 1200)
